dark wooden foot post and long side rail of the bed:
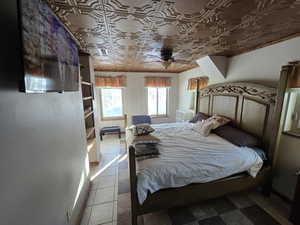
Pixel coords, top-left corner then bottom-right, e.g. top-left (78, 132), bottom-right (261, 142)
top-left (129, 146), bottom-right (271, 225)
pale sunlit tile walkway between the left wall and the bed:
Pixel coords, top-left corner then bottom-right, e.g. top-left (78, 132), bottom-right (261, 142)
top-left (81, 135), bottom-right (122, 225)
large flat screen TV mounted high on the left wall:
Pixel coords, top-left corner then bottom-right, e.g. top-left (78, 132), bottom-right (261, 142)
top-left (19, 0), bottom-right (79, 93)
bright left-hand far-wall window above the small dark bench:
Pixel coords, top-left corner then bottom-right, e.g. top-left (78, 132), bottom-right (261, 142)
top-left (101, 88), bottom-right (124, 120)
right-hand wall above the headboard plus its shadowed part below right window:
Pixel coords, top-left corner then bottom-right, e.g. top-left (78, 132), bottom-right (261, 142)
top-left (178, 38), bottom-right (300, 199)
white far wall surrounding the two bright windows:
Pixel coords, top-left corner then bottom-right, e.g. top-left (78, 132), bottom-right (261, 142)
top-left (95, 72), bottom-right (178, 131)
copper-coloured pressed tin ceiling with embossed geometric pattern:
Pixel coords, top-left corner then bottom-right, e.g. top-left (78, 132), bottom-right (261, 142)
top-left (48, 0), bottom-right (300, 72)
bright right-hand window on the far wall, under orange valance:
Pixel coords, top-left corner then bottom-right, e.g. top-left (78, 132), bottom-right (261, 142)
top-left (148, 87), bottom-right (168, 116)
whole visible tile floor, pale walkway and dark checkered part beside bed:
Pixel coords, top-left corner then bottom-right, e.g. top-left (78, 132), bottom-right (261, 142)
top-left (81, 136), bottom-right (291, 225)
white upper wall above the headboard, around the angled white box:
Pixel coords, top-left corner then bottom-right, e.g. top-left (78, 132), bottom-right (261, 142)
top-left (179, 38), bottom-right (300, 109)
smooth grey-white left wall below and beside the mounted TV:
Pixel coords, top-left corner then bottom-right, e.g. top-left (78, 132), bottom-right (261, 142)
top-left (0, 1), bottom-right (88, 225)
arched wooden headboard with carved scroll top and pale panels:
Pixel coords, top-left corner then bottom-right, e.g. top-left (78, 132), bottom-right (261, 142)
top-left (198, 83), bottom-right (276, 156)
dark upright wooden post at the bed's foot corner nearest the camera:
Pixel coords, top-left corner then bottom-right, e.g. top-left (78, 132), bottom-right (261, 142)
top-left (129, 146), bottom-right (139, 225)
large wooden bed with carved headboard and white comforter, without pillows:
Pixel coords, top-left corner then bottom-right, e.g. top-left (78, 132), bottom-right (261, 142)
top-left (128, 83), bottom-right (276, 225)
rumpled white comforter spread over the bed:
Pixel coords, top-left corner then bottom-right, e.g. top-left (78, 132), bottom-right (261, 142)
top-left (130, 123), bottom-right (263, 204)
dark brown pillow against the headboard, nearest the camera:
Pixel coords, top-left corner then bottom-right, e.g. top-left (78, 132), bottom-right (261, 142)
top-left (213, 125), bottom-right (260, 147)
